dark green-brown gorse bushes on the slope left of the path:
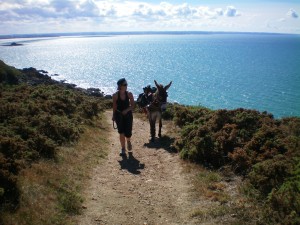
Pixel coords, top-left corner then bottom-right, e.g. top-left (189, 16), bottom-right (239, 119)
top-left (0, 61), bottom-right (105, 212)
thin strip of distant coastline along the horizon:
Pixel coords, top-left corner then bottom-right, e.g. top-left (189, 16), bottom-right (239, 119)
top-left (0, 31), bottom-right (300, 39)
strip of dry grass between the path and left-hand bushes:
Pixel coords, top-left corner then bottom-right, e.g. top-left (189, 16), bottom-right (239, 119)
top-left (2, 115), bottom-right (108, 225)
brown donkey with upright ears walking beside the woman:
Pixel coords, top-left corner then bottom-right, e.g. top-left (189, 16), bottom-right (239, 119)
top-left (147, 80), bottom-right (172, 142)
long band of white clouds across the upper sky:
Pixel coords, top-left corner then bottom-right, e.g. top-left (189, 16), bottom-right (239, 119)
top-left (0, 0), bottom-right (239, 21)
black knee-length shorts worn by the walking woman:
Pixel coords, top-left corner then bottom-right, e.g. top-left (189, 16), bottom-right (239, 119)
top-left (115, 111), bottom-right (133, 138)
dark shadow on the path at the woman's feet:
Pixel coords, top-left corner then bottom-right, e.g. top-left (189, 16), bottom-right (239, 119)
top-left (118, 152), bottom-right (145, 175)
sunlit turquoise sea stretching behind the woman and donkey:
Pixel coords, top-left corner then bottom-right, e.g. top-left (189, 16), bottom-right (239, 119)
top-left (0, 34), bottom-right (300, 117)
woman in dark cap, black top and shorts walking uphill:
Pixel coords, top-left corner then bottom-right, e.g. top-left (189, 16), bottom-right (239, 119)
top-left (112, 78), bottom-right (134, 156)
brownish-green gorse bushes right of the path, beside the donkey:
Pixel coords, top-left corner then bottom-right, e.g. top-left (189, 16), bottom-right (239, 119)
top-left (174, 106), bottom-right (300, 224)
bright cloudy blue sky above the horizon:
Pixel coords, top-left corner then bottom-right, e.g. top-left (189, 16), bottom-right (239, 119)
top-left (0, 0), bottom-right (300, 35)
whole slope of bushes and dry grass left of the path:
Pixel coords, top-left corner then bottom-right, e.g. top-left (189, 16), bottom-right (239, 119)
top-left (0, 61), bottom-right (110, 224)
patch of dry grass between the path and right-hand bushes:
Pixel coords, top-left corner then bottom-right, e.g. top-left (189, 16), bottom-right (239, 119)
top-left (183, 162), bottom-right (262, 225)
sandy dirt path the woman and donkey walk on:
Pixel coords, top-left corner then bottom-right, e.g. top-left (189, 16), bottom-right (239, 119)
top-left (79, 111), bottom-right (203, 225)
